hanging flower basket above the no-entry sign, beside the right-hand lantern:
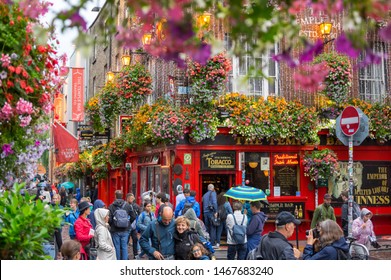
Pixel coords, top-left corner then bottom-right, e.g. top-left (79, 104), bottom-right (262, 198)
top-left (314, 52), bottom-right (352, 104)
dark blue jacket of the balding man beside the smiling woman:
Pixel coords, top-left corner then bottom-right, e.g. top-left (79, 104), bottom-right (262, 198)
top-left (139, 218), bottom-right (175, 260)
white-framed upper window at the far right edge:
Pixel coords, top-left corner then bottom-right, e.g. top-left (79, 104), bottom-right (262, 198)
top-left (359, 42), bottom-right (389, 102)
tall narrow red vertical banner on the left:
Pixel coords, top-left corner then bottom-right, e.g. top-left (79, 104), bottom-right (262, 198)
top-left (72, 68), bottom-right (84, 122)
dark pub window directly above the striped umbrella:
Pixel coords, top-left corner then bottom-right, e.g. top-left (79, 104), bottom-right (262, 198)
top-left (245, 153), bottom-right (270, 191)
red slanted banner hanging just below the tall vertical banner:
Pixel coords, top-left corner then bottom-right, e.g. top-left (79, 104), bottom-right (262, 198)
top-left (52, 122), bottom-right (79, 163)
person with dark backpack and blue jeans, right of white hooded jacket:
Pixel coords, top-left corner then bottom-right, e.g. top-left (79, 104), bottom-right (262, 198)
top-left (109, 190), bottom-right (131, 260)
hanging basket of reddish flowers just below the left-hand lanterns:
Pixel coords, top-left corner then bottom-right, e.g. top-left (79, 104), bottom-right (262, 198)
top-left (117, 63), bottom-right (152, 111)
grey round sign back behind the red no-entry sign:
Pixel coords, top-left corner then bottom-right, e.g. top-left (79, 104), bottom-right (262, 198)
top-left (335, 108), bottom-right (369, 146)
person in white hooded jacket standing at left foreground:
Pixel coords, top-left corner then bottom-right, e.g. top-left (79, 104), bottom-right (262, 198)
top-left (94, 208), bottom-right (117, 260)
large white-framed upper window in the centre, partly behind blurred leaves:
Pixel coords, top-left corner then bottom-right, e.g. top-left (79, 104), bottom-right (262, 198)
top-left (224, 34), bottom-right (279, 98)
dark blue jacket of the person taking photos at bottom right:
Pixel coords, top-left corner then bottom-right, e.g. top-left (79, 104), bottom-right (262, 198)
top-left (303, 237), bottom-right (349, 260)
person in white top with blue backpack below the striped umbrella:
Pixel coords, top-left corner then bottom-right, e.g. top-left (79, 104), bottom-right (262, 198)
top-left (226, 201), bottom-right (247, 260)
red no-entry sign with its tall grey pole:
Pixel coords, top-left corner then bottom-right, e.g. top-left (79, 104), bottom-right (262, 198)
top-left (337, 106), bottom-right (362, 237)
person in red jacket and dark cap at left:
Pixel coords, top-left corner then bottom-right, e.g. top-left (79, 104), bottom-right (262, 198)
top-left (74, 201), bottom-right (94, 256)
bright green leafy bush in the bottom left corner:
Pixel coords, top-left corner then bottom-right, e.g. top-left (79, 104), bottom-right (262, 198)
top-left (0, 184), bottom-right (64, 260)
